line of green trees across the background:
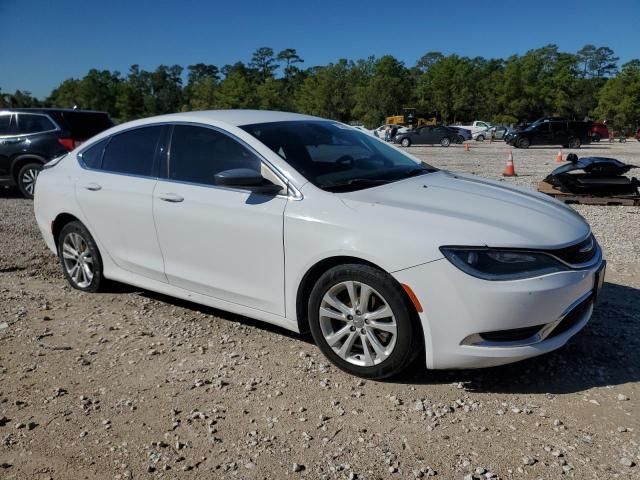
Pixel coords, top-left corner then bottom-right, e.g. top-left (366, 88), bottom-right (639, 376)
top-left (0, 45), bottom-right (640, 132)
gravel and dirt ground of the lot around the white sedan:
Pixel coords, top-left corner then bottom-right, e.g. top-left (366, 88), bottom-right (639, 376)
top-left (0, 142), bottom-right (640, 479)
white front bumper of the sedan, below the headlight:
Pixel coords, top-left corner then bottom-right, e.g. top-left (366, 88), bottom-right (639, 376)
top-left (393, 253), bottom-right (603, 369)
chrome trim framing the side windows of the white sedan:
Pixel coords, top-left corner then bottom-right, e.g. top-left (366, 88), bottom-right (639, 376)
top-left (76, 122), bottom-right (303, 200)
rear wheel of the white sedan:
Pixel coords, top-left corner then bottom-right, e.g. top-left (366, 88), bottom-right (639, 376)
top-left (58, 221), bottom-right (104, 293)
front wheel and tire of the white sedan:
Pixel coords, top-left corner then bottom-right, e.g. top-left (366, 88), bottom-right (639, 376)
top-left (308, 264), bottom-right (421, 379)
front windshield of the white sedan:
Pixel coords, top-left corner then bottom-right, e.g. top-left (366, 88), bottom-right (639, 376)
top-left (241, 120), bottom-right (437, 192)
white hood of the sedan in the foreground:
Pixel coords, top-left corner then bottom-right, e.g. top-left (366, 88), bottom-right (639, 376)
top-left (341, 171), bottom-right (590, 253)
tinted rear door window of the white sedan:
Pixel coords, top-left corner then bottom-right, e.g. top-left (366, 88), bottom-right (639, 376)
top-left (102, 126), bottom-right (163, 177)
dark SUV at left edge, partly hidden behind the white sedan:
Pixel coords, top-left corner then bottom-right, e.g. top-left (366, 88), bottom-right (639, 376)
top-left (0, 108), bottom-right (113, 198)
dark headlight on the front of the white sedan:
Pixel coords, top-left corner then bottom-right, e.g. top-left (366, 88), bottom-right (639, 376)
top-left (440, 247), bottom-right (568, 281)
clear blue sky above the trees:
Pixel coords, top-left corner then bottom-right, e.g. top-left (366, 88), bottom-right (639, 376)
top-left (0, 0), bottom-right (640, 97)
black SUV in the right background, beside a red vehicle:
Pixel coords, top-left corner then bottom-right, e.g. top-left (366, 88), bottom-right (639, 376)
top-left (505, 117), bottom-right (591, 148)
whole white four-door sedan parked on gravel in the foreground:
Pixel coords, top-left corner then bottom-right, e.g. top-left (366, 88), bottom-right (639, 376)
top-left (34, 110), bottom-right (604, 378)
